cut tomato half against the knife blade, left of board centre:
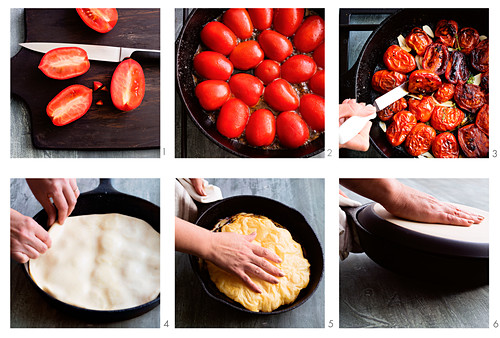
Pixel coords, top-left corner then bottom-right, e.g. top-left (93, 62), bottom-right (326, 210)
top-left (38, 47), bottom-right (90, 80)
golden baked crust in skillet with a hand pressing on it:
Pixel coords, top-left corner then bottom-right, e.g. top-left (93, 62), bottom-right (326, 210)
top-left (207, 213), bottom-right (310, 312)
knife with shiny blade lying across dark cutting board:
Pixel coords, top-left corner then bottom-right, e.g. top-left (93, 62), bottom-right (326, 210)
top-left (19, 42), bottom-right (160, 62)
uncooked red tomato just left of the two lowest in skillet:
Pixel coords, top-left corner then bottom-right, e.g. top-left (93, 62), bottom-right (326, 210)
top-left (216, 98), bottom-right (250, 138)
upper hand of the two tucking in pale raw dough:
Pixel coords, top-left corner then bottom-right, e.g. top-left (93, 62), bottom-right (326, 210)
top-left (26, 178), bottom-right (80, 225)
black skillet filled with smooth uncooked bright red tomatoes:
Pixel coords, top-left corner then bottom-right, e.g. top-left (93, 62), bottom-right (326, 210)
top-left (175, 8), bottom-right (325, 158)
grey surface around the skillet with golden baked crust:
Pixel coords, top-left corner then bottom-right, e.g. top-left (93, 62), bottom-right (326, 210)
top-left (175, 179), bottom-right (325, 328)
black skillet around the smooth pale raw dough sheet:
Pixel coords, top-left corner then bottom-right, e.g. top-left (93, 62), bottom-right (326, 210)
top-left (24, 179), bottom-right (160, 322)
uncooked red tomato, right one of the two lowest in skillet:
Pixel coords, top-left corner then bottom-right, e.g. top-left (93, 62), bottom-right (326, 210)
top-left (276, 111), bottom-right (309, 149)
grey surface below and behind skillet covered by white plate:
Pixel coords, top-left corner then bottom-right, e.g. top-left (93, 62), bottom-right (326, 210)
top-left (339, 179), bottom-right (489, 328)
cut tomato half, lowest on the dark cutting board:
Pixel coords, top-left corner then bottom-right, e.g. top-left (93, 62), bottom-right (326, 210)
top-left (47, 85), bottom-right (92, 126)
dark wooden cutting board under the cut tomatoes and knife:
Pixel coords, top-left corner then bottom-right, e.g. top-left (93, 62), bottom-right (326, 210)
top-left (11, 8), bottom-right (160, 150)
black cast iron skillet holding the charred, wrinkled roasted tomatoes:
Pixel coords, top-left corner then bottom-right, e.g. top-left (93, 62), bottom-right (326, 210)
top-left (341, 8), bottom-right (489, 157)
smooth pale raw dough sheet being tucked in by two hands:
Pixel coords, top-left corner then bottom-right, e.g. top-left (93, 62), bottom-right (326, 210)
top-left (29, 214), bottom-right (160, 310)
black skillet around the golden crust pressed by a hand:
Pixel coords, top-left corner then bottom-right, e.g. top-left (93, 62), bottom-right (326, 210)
top-left (190, 195), bottom-right (323, 315)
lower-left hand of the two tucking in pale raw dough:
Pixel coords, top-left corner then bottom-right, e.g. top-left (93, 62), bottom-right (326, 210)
top-left (10, 209), bottom-right (51, 263)
